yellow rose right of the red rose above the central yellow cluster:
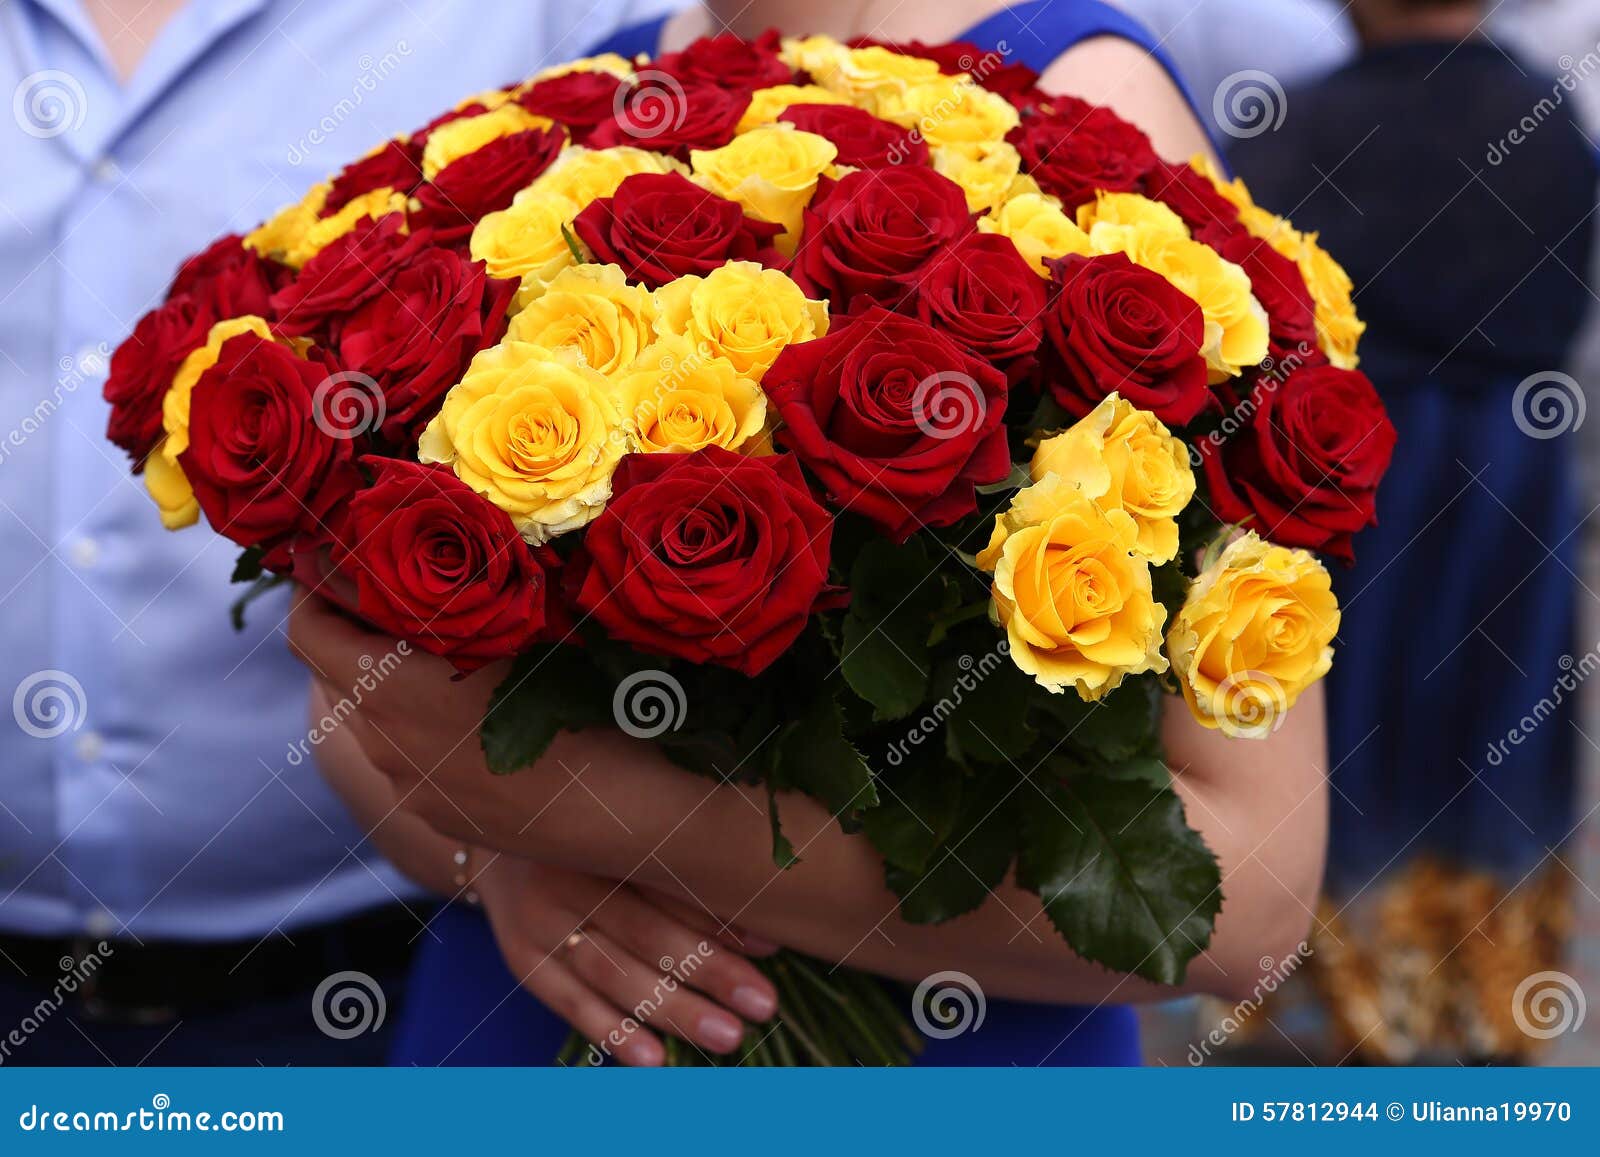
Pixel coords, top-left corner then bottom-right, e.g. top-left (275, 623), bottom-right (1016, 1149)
top-left (690, 125), bottom-right (838, 244)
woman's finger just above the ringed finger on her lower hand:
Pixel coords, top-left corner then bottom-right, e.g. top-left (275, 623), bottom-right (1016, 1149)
top-left (592, 888), bottom-right (778, 1024)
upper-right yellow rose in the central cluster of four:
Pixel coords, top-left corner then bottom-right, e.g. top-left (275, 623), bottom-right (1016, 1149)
top-left (656, 261), bottom-right (827, 381)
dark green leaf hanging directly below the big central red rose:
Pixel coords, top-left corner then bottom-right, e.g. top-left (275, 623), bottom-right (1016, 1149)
top-left (840, 538), bottom-right (944, 720)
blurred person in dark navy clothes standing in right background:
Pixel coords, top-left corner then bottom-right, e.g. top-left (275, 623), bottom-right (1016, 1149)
top-left (1230, 0), bottom-right (1600, 1063)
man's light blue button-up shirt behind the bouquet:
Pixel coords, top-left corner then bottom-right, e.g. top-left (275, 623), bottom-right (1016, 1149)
top-left (0, 0), bottom-right (664, 939)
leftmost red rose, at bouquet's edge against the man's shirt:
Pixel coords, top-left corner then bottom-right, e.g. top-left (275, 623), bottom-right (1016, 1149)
top-left (102, 294), bottom-right (214, 474)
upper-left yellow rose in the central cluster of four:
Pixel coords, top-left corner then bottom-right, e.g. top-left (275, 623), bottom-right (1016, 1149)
top-left (506, 264), bottom-right (656, 378)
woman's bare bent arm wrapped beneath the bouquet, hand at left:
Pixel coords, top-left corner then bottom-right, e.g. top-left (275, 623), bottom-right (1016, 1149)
top-left (290, 595), bottom-right (1326, 1003)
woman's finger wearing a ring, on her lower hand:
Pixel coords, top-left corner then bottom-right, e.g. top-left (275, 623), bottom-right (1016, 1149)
top-left (560, 925), bottom-right (744, 1053)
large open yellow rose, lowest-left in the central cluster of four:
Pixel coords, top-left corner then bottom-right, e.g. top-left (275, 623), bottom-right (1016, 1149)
top-left (418, 341), bottom-right (629, 546)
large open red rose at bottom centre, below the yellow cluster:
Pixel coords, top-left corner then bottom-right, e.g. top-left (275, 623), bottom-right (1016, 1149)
top-left (566, 446), bottom-right (834, 675)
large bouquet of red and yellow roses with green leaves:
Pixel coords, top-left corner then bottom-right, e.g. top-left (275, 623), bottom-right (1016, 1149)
top-left (106, 34), bottom-right (1395, 1063)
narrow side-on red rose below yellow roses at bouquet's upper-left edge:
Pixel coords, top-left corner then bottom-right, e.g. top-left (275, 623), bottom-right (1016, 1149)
top-left (272, 213), bottom-right (432, 338)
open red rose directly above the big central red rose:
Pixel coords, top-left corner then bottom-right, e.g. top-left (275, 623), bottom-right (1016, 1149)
top-left (790, 166), bottom-right (974, 314)
